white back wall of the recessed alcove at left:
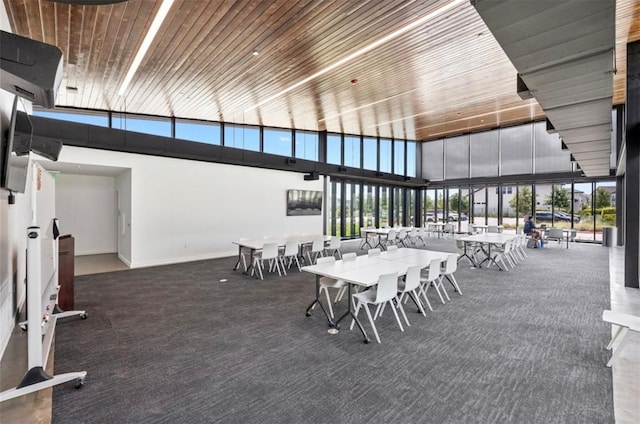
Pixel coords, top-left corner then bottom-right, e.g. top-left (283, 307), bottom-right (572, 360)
top-left (56, 174), bottom-right (117, 256)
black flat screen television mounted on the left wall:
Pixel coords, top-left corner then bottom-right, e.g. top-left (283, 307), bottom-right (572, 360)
top-left (0, 96), bottom-right (31, 193)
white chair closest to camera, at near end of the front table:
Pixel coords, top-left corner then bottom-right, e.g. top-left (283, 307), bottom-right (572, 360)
top-left (351, 272), bottom-right (404, 343)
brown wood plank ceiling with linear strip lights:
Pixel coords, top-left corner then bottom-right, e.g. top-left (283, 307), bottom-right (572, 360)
top-left (3, 0), bottom-right (640, 140)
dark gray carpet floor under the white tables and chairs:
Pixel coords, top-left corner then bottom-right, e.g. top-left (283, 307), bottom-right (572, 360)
top-left (53, 239), bottom-right (614, 424)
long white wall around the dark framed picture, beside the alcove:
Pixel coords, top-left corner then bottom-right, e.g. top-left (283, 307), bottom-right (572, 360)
top-left (59, 146), bottom-right (323, 268)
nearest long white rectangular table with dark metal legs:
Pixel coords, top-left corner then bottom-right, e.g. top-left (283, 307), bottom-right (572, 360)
top-left (302, 248), bottom-right (451, 343)
